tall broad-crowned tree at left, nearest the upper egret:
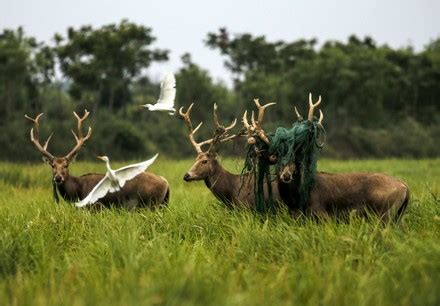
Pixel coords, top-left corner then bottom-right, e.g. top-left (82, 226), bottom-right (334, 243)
top-left (55, 20), bottom-right (168, 110)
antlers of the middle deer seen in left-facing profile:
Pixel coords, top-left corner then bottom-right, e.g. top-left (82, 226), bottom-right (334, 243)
top-left (179, 103), bottom-right (237, 153)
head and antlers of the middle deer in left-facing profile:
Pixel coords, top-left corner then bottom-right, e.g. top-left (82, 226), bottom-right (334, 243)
top-left (179, 103), bottom-right (237, 182)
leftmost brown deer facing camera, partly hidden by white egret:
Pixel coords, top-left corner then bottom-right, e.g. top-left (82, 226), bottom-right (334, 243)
top-left (25, 110), bottom-right (170, 209)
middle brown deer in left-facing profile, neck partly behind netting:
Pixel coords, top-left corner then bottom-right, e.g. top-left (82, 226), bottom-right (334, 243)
top-left (179, 103), bottom-right (279, 209)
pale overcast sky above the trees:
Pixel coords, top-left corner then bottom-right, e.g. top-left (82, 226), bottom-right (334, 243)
top-left (0, 0), bottom-right (440, 83)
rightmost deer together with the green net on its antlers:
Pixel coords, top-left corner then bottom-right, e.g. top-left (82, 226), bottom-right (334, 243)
top-left (243, 94), bottom-right (410, 220)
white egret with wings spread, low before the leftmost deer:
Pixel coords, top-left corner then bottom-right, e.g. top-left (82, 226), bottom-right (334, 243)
top-left (75, 154), bottom-right (159, 207)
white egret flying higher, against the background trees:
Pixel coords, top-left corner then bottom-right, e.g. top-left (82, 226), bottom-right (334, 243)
top-left (142, 73), bottom-right (176, 115)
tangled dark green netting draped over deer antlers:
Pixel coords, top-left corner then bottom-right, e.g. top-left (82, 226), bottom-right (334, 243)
top-left (242, 120), bottom-right (325, 212)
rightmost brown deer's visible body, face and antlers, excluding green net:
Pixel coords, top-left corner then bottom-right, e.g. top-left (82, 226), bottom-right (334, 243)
top-left (243, 94), bottom-right (410, 221)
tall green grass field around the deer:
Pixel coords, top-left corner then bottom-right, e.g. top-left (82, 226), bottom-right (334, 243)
top-left (0, 158), bottom-right (440, 306)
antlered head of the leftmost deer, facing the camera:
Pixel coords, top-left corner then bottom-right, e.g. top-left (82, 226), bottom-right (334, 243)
top-left (25, 110), bottom-right (92, 185)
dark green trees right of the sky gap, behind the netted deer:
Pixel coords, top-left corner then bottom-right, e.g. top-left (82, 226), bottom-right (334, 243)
top-left (206, 29), bottom-right (440, 156)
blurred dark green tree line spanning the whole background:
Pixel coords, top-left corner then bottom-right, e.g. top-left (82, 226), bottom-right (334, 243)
top-left (0, 20), bottom-right (440, 161)
